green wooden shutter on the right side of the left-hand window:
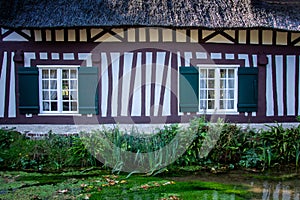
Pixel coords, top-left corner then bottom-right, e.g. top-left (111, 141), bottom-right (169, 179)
top-left (78, 67), bottom-right (98, 115)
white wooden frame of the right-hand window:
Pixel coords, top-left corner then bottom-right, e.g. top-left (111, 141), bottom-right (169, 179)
top-left (197, 65), bottom-right (239, 114)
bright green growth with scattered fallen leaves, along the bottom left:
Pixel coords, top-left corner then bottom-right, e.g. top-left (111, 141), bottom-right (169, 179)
top-left (0, 171), bottom-right (251, 200)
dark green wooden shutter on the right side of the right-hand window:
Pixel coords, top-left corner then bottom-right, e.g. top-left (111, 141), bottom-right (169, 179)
top-left (238, 67), bottom-right (258, 112)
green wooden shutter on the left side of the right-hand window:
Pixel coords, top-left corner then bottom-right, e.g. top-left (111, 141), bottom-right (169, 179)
top-left (179, 67), bottom-right (199, 112)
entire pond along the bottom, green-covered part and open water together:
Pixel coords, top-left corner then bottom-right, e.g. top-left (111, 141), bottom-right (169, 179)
top-left (0, 170), bottom-right (300, 200)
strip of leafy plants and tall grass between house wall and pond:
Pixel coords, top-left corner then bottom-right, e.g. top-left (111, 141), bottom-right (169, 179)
top-left (0, 118), bottom-right (300, 174)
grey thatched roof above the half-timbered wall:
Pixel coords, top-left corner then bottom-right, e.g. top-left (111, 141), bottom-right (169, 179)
top-left (0, 0), bottom-right (300, 31)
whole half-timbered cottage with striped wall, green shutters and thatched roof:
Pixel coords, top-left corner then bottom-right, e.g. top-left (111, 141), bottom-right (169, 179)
top-left (0, 0), bottom-right (300, 133)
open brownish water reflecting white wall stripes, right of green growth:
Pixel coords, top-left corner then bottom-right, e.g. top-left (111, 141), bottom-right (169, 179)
top-left (174, 170), bottom-right (300, 200)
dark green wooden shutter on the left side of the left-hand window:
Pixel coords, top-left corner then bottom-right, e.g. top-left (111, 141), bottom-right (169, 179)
top-left (18, 67), bottom-right (39, 114)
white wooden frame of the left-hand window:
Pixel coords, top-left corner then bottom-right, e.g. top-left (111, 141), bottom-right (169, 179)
top-left (37, 65), bottom-right (80, 115)
